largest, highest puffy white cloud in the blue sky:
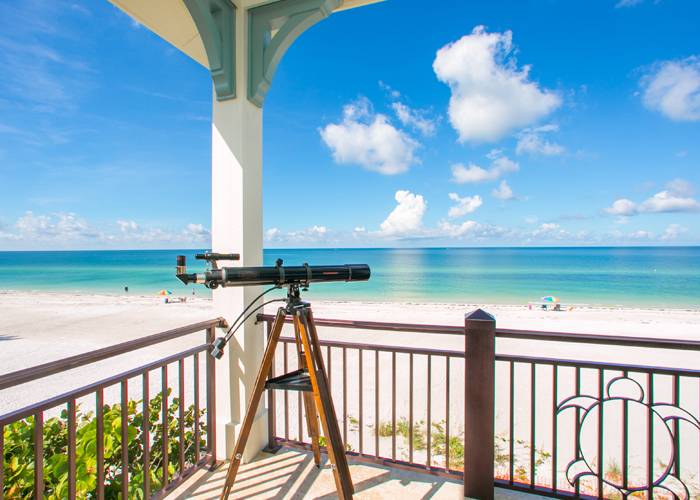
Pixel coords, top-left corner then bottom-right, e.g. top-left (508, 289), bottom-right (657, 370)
top-left (433, 26), bottom-right (562, 142)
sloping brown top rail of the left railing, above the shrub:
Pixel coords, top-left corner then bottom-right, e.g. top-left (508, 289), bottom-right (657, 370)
top-left (0, 318), bottom-right (226, 390)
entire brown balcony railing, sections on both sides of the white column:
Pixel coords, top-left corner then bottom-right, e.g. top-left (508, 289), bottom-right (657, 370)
top-left (0, 315), bottom-right (700, 499)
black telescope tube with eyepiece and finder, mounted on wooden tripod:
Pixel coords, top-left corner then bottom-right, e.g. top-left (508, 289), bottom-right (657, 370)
top-left (176, 253), bottom-right (370, 289)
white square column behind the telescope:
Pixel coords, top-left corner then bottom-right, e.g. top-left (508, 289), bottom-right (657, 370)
top-left (212, 4), bottom-right (267, 461)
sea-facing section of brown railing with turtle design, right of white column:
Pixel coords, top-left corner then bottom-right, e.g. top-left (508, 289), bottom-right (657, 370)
top-left (258, 315), bottom-right (700, 498)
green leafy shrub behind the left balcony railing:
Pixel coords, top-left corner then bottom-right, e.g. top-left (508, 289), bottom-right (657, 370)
top-left (3, 390), bottom-right (206, 499)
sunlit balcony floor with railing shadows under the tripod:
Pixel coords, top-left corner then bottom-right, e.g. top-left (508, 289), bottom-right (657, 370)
top-left (168, 448), bottom-right (543, 500)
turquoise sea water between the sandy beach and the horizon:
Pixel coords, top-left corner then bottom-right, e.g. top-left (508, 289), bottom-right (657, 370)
top-left (0, 247), bottom-right (700, 309)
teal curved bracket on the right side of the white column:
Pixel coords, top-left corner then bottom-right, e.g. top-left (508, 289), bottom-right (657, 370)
top-left (248, 0), bottom-right (343, 107)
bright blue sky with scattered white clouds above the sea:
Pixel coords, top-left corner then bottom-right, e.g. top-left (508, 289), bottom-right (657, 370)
top-left (0, 0), bottom-right (700, 250)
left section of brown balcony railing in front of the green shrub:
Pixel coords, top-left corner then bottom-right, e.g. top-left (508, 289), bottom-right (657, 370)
top-left (0, 318), bottom-right (223, 499)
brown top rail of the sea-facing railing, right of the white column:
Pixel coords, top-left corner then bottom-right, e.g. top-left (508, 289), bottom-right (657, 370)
top-left (257, 314), bottom-right (700, 351)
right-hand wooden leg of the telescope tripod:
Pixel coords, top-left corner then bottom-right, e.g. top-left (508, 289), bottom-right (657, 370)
top-left (295, 309), bottom-right (353, 500)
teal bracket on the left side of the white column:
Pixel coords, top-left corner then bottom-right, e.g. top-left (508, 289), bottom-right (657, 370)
top-left (184, 0), bottom-right (236, 101)
